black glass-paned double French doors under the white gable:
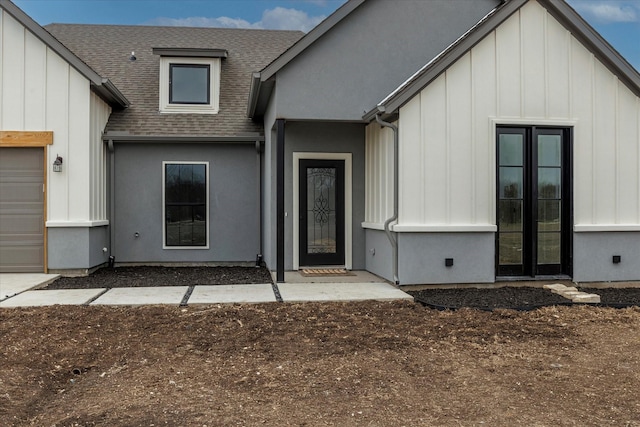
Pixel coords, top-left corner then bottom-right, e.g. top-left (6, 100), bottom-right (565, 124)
top-left (496, 127), bottom-right (571, 277)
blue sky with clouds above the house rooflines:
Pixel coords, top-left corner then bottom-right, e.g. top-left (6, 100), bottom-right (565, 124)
top-left (13, 0), bottom-right (640, 70)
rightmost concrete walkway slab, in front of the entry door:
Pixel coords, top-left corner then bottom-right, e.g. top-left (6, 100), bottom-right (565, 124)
top-left (278, 283), bottom-right (413, 302)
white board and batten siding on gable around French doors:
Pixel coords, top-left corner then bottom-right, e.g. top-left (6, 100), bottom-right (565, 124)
top-left (367, 2), bottom-right (640, 231)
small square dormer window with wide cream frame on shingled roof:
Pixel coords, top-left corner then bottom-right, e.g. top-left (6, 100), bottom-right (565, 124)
top-left (159, 56), bottom-right (220, 114)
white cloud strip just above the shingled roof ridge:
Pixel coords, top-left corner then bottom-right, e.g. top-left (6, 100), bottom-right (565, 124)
top-left (145, 7), bottom-right (325, 32)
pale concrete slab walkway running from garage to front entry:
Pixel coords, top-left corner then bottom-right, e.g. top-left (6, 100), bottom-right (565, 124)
top-left (0, 274), bottom-right (413, 308)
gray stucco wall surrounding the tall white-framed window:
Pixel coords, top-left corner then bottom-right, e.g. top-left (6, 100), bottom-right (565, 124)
top-left (113, 144), bottom-right (260, 263)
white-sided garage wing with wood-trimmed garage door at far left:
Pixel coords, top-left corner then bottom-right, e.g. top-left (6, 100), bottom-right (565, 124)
top-left (0, 1), bottom-right (128, 272)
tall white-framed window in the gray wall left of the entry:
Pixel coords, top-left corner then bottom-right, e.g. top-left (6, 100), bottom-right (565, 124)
top-left (162, 161), bottom-right (209, 249)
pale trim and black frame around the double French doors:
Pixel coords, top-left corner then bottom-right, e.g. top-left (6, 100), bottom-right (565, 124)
top-left (490, 122), bottom-right (577, 279)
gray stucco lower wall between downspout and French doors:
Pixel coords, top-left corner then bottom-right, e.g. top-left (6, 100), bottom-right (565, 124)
top-left (398, 233), bottom-right (495, 285)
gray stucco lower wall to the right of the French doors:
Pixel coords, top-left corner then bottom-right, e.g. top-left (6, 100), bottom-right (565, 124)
top-left (573, 232), bottom-right (640, 282)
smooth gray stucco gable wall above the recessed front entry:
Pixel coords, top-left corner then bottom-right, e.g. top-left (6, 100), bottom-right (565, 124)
top-left (276, 0), bottom-right (499, 120)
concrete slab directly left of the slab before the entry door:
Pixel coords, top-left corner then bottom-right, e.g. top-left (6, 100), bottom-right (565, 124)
top-left (187, 284), bottom-right (276, 304)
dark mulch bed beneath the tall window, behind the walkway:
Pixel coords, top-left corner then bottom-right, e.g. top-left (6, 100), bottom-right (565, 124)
top-left (45, 266), bottom-right (271, 289)
